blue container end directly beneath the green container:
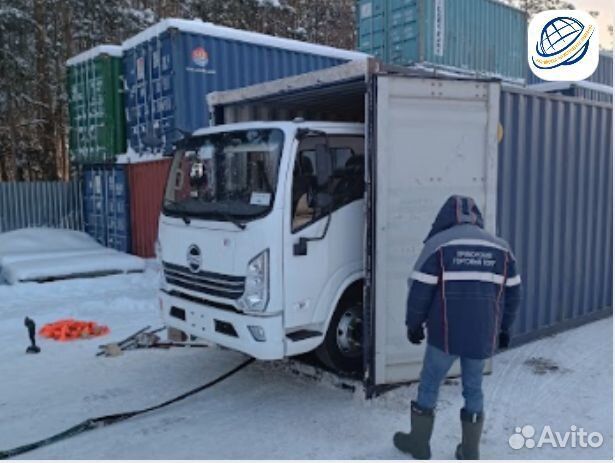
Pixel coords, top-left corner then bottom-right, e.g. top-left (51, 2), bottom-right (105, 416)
top-left (83, 164), bottom-right (131, 252)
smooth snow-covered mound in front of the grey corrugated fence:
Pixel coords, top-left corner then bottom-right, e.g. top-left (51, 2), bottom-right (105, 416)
top-left (0, 228), bottom-right (145, 284)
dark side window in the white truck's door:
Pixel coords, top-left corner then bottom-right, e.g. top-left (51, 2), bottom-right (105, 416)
top-left (291, 136), bottom-right (364, 233)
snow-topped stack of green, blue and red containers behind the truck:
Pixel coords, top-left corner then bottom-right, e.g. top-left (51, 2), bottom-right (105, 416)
top-left (75, 19), bottom-right (366, 257)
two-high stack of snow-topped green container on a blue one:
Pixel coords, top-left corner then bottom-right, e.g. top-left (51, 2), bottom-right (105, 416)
top-left (66, 45), bottom-right (130, 252)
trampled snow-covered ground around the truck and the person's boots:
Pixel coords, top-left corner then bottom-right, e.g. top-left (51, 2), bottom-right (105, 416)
top-left (0, 268), bottom-right (613, 459)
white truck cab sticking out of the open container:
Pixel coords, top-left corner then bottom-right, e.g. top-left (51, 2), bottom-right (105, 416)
top-left (158, 119), bottom-right (365, 373)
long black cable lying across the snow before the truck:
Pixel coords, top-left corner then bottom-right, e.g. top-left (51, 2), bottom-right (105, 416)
top-left (0, 358), bottom-right (254, 460)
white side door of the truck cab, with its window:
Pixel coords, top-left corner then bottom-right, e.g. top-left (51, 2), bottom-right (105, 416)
top-left (284, 134), bottom-right (364, 329)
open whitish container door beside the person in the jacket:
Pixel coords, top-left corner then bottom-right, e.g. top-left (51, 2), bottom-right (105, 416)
top-left (366, 76), bottom-right (499, 395)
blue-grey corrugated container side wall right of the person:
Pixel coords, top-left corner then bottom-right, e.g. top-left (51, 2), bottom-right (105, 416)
top-left (497, 90), bottom-right (613, 342)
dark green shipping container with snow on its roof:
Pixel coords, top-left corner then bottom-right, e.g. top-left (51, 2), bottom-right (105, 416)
top-left (66, 45), bottom-right (126, 163)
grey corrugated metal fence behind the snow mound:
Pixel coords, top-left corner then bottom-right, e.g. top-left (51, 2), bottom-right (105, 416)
top-left (0, 180), bottom-right (83, 233)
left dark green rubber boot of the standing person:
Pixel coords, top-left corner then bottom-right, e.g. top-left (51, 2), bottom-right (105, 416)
top-left (393, 401), bottom-right (435, 460)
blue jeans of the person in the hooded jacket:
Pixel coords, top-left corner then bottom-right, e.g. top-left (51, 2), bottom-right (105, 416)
top-left (416, 344), bottom-right (485, 413)
